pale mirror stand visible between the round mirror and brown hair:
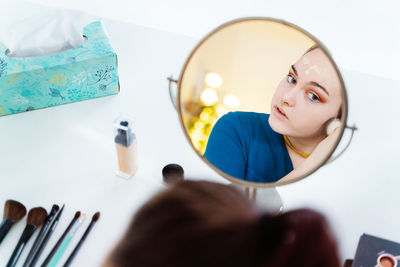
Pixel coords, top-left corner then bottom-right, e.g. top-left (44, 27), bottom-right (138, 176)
top-left (231, 184), bottom-right (283, 214)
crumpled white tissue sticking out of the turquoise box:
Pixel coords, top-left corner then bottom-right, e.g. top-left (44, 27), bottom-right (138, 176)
top-left (0, 0), bottom-right (99, 57)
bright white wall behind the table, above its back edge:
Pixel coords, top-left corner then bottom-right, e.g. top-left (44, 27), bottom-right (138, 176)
top-left (25, 0), bottom-right (400, 80)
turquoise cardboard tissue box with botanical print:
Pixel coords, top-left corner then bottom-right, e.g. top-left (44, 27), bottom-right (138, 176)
top-left (0, 21), bottom-right (119, 116)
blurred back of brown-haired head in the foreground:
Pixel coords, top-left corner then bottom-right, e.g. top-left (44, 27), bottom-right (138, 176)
top-left (106, 181), bottom-right (338, 267)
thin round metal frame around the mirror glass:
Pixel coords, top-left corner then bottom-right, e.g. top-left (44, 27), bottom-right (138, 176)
top-left (176, 17), bottom-right (348, 188)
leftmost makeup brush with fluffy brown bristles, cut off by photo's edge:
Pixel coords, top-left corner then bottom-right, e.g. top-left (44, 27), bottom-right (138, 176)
top-left (0, 199), bottom-right (26, 244)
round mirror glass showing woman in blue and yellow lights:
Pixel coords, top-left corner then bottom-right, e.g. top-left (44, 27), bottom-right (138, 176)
top-left (179, 20), bottom-right (346, 183)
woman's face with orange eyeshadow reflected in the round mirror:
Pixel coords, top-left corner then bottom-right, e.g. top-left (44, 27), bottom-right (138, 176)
top-left (269, 48), bottom-right (342, 138)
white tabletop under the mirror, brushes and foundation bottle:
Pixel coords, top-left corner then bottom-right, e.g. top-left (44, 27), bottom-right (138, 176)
top-left (0, 20), bottom-right (400, 266)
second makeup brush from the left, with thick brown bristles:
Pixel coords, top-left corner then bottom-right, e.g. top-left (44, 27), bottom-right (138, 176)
top-left (7, 207), bottom-right (47, 267)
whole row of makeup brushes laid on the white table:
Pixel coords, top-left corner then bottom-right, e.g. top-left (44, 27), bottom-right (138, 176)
top-left (0, 200), bottom-right (100, 267)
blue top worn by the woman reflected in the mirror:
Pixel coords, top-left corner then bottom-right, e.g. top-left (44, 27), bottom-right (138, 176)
top-left (204, 111), bottom-right (293, 183)
